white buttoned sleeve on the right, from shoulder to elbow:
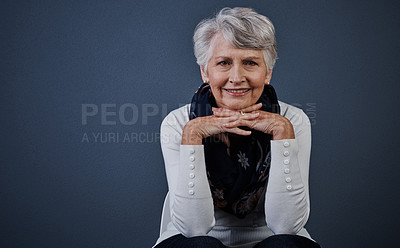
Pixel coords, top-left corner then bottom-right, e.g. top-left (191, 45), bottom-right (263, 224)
top-left (265, 109), bottom-right (311, 234)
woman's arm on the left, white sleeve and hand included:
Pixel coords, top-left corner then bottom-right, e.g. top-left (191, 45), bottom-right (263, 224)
top-left (161, 105), bottom-right (261, 237)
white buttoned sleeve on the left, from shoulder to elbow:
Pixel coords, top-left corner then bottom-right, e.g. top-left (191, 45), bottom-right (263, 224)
top-left (161, 108), bottom-right (215, 237)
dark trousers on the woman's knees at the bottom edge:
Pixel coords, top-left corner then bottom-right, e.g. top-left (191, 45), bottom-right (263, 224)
top-left (155, 234), bottom-right (321, 248)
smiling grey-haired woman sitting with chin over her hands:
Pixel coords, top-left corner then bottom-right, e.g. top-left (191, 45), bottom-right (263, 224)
top-left (155, 8), bottom-right (320, 248)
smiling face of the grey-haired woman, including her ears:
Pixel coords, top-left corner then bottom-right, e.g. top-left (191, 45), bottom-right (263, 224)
top-left (201, 34), bottom-right (272, 110)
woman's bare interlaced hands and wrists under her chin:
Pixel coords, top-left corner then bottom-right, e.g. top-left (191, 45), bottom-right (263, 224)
top-left (182, 103), bottom-right (295, 145)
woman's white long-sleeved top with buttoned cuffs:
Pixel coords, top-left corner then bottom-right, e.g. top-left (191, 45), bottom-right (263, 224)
top-left (156, 102), bottom-right (311, 248)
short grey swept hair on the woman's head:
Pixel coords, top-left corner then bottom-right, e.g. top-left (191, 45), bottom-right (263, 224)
top-left (193, 8), bottom-right (278, 73)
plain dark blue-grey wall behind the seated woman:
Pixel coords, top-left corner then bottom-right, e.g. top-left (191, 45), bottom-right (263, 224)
top-left (0, 0), bottom-right (400, 248)
